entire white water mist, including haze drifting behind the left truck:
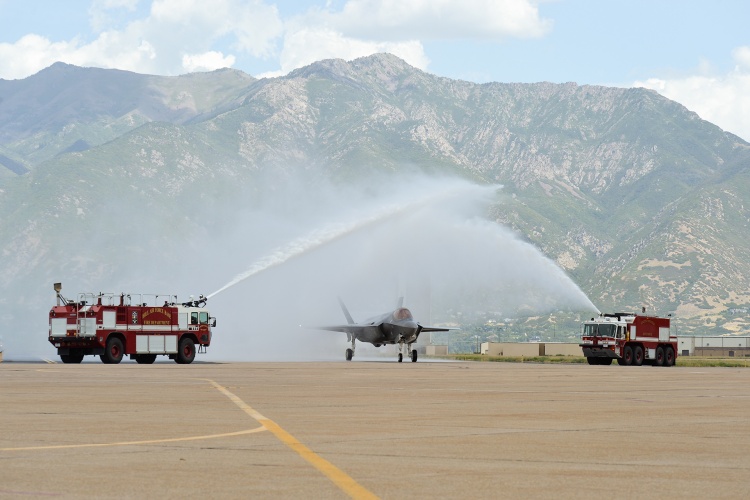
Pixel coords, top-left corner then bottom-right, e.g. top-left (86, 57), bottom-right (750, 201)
top-left (4, 173), bottom-right (596, 360)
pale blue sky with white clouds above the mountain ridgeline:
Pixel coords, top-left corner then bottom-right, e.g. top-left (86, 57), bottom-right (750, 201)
top-left (0, 0), bottom-right (750, 140)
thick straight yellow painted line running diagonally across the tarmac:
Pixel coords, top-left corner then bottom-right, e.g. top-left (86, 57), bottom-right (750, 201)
top-left (204, 379), bottom-right (378, 498)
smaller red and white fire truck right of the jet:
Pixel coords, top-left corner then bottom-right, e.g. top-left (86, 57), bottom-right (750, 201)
top-left (580, 313), bottom-right (677, 366)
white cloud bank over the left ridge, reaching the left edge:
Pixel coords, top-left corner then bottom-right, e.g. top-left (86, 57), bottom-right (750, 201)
top-left (0, 0), bottom-right (283, 78)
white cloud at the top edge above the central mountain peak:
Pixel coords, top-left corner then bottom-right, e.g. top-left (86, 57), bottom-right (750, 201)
top-left (268, 0), bottom-right (551, 76)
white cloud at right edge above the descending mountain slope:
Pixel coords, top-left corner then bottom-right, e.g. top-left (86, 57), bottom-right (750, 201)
top-left (634, 46), bottom-right (750, 141)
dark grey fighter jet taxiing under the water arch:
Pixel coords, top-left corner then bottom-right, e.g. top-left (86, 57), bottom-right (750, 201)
top-left (316, 297), bottom-right (455, 363)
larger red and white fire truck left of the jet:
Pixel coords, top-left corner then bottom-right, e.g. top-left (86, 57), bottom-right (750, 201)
top-left (49, 283), bottom-right (216, 364)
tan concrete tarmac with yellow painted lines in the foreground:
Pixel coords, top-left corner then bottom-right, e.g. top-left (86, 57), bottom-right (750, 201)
top-left (0, 361), bottom-right (750, 498)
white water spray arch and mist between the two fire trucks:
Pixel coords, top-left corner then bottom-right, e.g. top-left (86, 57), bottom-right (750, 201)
top-left (197, 176), bottom-right (596, 360)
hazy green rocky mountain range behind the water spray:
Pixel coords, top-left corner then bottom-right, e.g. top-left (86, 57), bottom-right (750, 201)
top-left (0, 54), bottom-right (750, 352)
